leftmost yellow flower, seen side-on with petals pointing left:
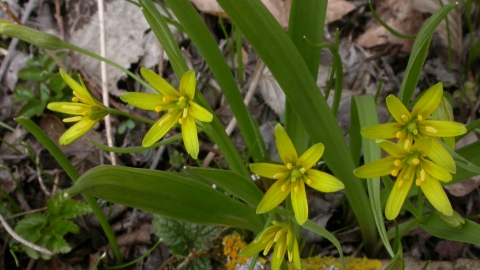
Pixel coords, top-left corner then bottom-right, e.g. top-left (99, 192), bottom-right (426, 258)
top-left (47, 69), bottom-right (108, 145)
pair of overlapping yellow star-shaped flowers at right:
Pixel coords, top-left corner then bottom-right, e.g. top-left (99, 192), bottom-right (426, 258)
top-left (354, 83), bottom-right (467, 220)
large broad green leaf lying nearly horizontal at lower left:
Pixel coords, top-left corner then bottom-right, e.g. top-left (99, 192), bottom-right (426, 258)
top-left (67, 165), bottom-right (263, 232)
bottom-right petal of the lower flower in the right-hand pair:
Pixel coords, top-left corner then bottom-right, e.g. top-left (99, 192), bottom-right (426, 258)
top-left (420, 177), bottom-right (453, 216)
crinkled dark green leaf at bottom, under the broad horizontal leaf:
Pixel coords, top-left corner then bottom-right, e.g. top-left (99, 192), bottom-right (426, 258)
top-left (152, 215), bottom-right (220, 255)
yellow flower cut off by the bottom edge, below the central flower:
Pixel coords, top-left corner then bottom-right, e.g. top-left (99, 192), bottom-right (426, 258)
top-left (238, 221), bottom-right (301, 270)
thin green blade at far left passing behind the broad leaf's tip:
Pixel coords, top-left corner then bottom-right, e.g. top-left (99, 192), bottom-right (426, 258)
top-left (15, 117), bottom-right (123, 264)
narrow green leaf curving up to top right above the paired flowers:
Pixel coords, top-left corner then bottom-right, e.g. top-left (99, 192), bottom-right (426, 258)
top-left (398, 2), bottom-right (458, 105)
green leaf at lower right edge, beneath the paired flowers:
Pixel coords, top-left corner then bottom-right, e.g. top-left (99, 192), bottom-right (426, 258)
top-left (418, 213), bottom-right (480, 246)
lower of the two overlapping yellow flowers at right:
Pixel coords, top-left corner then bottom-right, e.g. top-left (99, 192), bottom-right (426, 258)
top-left (354, 137), bottom-right (453, 220)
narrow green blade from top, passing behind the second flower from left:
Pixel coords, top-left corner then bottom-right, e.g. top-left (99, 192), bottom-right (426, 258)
top-left (139, 0), bottom-right (250, 179)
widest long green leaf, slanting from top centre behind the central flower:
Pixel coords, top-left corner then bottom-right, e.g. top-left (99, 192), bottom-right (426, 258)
top-left (217, 0), bottom-right (378, 251)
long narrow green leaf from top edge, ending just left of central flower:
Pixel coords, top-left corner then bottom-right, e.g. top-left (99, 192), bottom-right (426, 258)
top-left (165, 0), bottom-right (269, 162)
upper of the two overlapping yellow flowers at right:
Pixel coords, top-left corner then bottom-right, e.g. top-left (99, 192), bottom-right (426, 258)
top-left (361, 83), bottom-right (467, 173)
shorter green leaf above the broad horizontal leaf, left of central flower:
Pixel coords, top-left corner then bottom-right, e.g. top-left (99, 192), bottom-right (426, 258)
top-left (186, 167), bottom-right (263, 208)
